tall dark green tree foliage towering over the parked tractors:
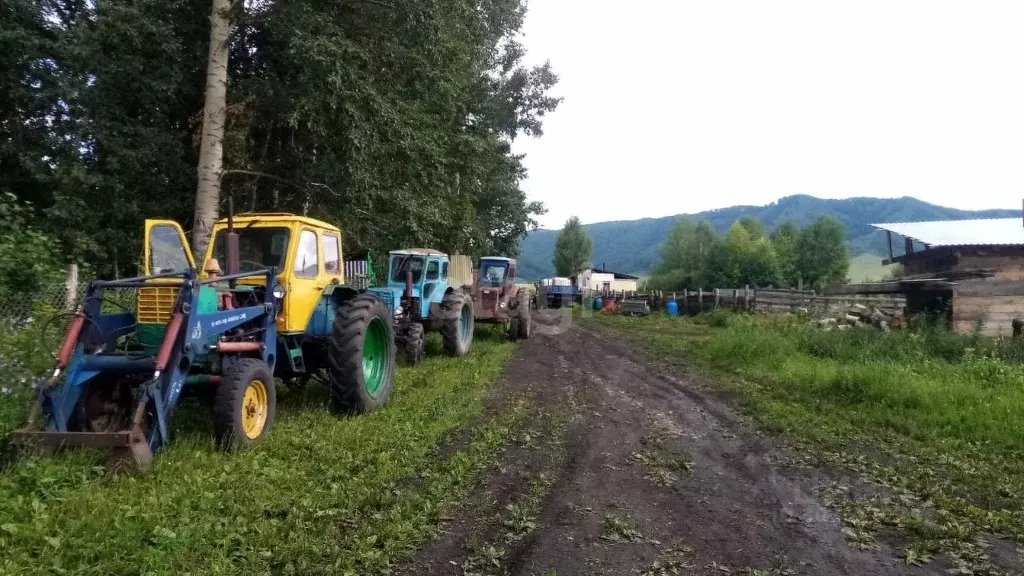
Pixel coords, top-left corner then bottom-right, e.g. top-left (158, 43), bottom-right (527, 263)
top-left (0, 0), bottom-right (560, 274)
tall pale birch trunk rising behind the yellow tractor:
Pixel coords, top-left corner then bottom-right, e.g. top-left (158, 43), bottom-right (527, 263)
top-left (191, 0), bottom-right (231, 259)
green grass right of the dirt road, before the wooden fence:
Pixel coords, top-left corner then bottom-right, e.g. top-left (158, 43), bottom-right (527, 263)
top-left (593, 314), bottom-right (1024, 573)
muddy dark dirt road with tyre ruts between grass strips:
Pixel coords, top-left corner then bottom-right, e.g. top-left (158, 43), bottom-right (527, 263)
top-left (401, 313), bottom-right (942, 576)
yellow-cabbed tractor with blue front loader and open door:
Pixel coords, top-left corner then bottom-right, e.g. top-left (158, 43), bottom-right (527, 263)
top-left (13, 213), bottom-right (395, 467)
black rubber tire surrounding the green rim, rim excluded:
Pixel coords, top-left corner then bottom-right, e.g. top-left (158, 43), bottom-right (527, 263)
top-left (328, 295), bottom-right (395, 414)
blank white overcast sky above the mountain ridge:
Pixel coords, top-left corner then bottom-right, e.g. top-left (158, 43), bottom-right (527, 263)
top-left (515, 0), bottom-right (1024, 228)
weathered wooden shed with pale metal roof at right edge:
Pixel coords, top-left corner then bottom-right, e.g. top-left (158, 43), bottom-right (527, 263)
top-left (831, 218), bottom-right (1024, 336)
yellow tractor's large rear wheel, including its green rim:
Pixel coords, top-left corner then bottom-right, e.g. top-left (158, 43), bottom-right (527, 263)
top-left (328, 295), bottom-right (395, 414)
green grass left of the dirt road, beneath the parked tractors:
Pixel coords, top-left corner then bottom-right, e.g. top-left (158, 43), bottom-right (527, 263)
top-left (0, 332), bottom-right (522, 574)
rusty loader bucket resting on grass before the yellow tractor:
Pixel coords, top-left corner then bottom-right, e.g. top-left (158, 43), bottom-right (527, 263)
top-left (11, 427), bottom-right (153, 472)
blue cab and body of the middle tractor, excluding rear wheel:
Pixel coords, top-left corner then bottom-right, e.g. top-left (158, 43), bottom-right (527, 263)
top-left (370, 248), bottom-right (449, 320)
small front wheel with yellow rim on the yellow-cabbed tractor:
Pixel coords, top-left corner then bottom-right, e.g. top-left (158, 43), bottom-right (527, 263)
top-left (213, 358), bottom-right (278, 450)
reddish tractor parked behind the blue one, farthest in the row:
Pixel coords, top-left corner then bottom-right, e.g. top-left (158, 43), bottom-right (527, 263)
top-left (473, 256), bottom-right (532, 340)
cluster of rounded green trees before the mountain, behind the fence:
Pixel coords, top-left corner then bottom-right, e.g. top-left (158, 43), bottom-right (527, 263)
top-left (649, 216), bottom-right (850, 290)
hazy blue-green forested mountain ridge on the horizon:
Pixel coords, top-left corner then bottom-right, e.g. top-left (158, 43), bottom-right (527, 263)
top-left (519, 195), bottom-right (1021, 279)
